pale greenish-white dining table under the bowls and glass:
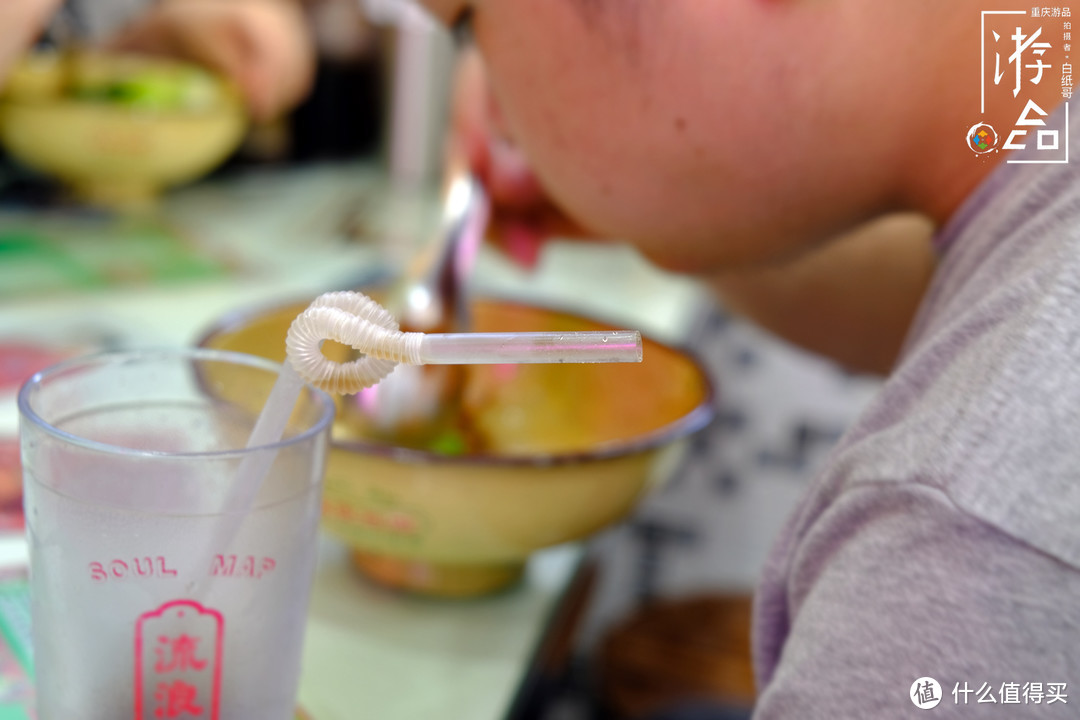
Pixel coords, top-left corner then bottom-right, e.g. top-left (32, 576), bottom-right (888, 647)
top-left (0, 161), bottom-right (702, 720)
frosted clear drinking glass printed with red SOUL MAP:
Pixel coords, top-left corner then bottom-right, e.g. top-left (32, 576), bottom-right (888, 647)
top-left (18, 349), bottom-right (334, 720)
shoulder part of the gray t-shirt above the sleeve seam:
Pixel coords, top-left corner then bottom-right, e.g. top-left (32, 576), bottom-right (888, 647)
top-left (812, 184), bottom-right (1080, 567)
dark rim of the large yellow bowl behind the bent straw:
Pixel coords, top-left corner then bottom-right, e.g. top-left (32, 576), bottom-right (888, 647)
top-left (195, 289), bottom-right (719, 467)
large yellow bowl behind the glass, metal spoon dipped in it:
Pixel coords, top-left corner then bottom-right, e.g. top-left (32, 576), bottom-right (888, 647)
top-left (201, 299), bottom-right (714, 596)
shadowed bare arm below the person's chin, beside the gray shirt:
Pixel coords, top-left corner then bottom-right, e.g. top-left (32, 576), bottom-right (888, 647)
top-left (711, 215), bottom-right (935, 373)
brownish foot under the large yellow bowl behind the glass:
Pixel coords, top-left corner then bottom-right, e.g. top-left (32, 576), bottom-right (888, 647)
top-left (350, 551), bottom-right (525, 598)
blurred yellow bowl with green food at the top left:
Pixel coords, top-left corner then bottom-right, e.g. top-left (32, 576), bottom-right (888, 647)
top-left (0, 53), bottom-right (247, 208)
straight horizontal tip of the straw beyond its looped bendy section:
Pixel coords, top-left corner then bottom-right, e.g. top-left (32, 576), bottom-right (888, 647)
top-left (419, 330), bottom-right (642, 365)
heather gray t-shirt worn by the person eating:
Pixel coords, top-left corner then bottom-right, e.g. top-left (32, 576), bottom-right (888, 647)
top-left (754, 104), bottom-right (1080, 720)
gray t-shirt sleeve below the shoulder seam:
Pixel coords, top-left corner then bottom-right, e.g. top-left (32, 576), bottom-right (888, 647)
top-left (754, 483), bottom-right (1080, 720)
